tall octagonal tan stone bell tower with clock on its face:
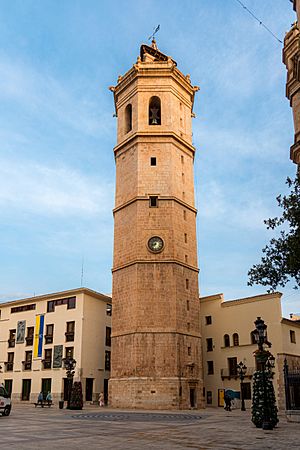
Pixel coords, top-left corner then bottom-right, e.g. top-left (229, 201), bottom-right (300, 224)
top-left (109, 40), bottom-right (203, 409)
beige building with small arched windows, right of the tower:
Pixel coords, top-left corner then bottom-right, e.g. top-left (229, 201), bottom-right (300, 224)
top-left (200, 292), bottom-right (300, 409)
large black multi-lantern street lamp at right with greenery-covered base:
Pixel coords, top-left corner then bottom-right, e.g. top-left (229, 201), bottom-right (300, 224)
top-left (252, 317), bottom-right (278, 430)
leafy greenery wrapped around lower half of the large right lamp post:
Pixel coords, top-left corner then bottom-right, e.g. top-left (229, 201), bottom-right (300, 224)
top-left (251, 370), bottom-right (278, 428)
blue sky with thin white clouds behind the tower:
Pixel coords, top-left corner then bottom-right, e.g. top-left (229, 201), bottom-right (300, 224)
top-left (0, 0), bottom-right (300, 314)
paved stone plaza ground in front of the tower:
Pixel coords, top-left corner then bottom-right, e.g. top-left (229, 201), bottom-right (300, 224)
top-left (0, 405), bottom-right (300, 450)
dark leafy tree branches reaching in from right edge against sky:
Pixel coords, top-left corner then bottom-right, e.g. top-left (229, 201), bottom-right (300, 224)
top-left (248, 172), bottom-right (300, 291)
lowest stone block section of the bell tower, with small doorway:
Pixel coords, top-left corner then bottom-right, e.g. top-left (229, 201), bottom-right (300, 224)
top-left (108, 377), bottom-right (204, 410)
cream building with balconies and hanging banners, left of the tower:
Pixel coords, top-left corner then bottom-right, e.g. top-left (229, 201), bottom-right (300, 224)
top-left (0, 288), bottom-right (112, 402)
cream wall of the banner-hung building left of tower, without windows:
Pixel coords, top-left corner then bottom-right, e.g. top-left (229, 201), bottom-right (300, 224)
top-left (0, 289), bottom-right (110, 401)
